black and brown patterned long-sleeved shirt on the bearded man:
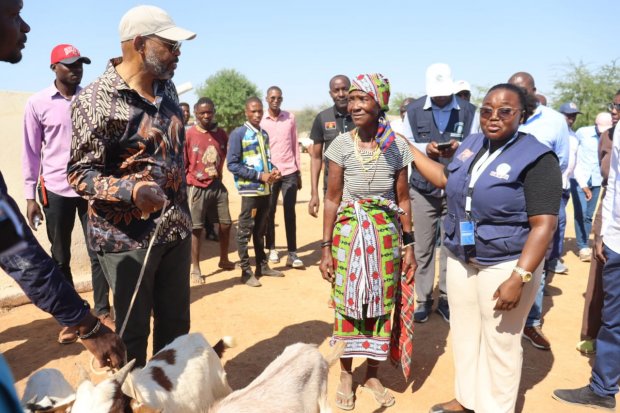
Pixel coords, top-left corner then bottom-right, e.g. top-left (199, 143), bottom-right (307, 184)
top-left (68, 58), bottom-right (192, 252)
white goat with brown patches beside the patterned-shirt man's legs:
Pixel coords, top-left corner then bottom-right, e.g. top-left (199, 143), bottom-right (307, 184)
top-left (21, 333), bottom-right (232, 413)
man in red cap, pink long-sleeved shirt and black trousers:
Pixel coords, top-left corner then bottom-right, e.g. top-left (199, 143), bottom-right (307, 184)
top-left (22, 44), bottom-right (114, 344)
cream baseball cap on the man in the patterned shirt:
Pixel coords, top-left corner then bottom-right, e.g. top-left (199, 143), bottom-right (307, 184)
top-left (118, 6), bottom-right (196, 42)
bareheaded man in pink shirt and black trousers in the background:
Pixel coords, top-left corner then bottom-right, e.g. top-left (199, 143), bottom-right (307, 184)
top-left (260, 86), bottom-right (304, 268)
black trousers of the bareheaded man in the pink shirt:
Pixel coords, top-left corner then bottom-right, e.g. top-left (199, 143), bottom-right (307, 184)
top-left (265, 172), bottom-right (298, 252)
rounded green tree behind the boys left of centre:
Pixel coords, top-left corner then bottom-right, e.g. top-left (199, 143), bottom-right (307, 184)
top-left (196, 69), bottom-right (262, 133)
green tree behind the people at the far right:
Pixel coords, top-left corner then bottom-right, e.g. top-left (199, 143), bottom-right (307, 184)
top-left (551, 60), bottom-right (620, 129)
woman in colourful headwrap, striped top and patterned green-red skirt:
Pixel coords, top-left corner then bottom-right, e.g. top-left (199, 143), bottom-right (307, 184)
top-left (320, 74), bottom-right (416, 410)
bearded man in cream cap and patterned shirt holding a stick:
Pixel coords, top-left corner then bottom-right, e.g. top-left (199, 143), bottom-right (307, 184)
top-left (68, 6), bottom-right (196, 365)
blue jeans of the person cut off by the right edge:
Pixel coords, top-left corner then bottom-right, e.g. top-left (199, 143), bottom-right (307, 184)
top-left (590, 246), bottom-right (620, 396)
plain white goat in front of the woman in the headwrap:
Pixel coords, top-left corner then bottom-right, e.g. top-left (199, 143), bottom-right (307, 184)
top-left (209, 342), bottom-right (345, 413)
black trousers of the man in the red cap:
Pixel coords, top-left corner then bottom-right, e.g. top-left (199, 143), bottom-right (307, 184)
top-left (43, 190), bottom-right (110, 315)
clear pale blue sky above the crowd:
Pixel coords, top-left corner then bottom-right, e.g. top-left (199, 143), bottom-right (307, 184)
top-left (0, 0), bottom-right (620, 109)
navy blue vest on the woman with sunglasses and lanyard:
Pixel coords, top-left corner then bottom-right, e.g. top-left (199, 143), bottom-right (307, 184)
top-left (444, 133), bottom-right (551, 265)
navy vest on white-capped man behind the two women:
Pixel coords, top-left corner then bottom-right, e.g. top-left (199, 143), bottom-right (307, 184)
top-left (407, 96), bottom-right (476, 197)
